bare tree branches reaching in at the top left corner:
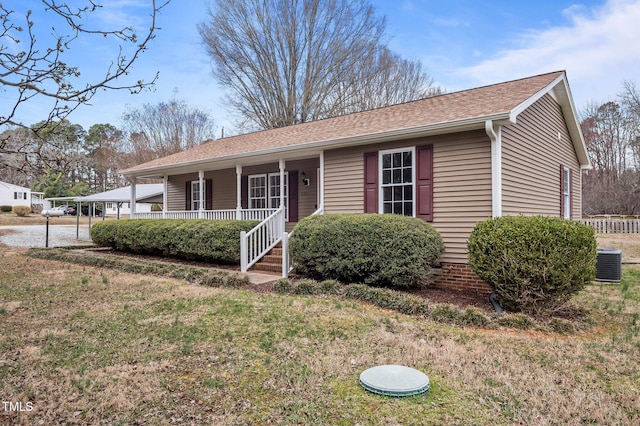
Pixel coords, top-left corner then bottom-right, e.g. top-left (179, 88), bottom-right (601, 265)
top-left (0, 0), bottom-right (170, 176)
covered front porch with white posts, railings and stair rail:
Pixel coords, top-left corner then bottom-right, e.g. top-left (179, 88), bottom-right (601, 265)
top-left (130, 152), bottom-right (324, 276)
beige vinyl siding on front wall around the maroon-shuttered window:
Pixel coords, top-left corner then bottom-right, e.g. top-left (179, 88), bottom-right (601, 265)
top-left (325, 130), bottom-right (491, 263)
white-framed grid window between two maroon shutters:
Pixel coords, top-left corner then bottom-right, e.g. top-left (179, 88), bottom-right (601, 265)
top-left (380, 148), bottom-right (415, 216)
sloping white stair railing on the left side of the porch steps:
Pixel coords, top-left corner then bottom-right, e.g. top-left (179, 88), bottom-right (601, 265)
top-left (240, 207), bottom-right (285, 272)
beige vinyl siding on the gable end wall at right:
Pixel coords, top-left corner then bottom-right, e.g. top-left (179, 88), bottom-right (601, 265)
top-left (502, 95), bottom-right (582, 219)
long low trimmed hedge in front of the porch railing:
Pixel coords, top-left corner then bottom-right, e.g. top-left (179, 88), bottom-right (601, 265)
top-left (91, 219), bottom-right (258, 264)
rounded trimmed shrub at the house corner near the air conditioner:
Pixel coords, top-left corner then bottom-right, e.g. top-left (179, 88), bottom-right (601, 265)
top-left (468, 216), bottom-right (597, 311)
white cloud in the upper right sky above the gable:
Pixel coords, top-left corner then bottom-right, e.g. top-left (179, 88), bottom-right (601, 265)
top-left (456, 0), bottom-right (640, 107)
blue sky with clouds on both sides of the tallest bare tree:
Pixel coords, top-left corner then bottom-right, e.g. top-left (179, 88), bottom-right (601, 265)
top-left (5, 0), bottom-right (640, 135)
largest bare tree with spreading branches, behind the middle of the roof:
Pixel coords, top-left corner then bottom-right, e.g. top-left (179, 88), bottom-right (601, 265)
top-left (198, 0), bottom-right (440, 128)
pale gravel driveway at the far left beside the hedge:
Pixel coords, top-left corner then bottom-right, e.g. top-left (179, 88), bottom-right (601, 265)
top-left (0, 225), bottom-right (91, 247)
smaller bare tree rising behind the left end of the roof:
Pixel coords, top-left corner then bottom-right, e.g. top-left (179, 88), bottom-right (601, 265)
top-left (122, 99), bottom-right (215, 165)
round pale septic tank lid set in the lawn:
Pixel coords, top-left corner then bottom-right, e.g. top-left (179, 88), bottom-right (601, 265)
top-left (360, 365), bottom-right (431, 396)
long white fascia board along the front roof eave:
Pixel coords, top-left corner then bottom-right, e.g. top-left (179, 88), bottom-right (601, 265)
top-left (122, 113), bottom-right (509, 177)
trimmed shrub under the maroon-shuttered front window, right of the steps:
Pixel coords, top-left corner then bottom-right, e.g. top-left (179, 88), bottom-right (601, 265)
top-left (290, 214), bottom-right (444, 287)
